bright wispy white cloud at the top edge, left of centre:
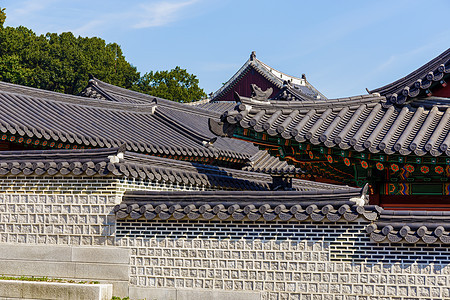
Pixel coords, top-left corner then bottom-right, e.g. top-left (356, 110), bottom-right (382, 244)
top-left (133, 0), bottom-right (198, 28)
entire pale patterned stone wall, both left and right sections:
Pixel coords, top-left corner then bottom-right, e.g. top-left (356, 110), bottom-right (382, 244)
top-left (0, 177), bottom-right (450, 300)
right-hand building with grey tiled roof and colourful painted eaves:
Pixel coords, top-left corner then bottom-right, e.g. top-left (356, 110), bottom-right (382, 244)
top-left (210, 50), bottom-right (450, 210)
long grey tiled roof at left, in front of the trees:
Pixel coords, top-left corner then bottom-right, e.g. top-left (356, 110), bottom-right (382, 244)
top-left (0, 82), bottom-right (258, 165)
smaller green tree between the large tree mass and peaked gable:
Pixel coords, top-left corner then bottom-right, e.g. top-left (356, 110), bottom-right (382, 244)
top-left (133, 66), bottom-right (206, 102)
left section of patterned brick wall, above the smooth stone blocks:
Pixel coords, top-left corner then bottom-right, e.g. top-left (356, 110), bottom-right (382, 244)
top-left (0, 176), bottom-right (203, 245)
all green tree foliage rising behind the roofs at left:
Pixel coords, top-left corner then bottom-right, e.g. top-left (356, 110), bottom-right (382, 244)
top-left (0, 7), bottom-right (205, 101)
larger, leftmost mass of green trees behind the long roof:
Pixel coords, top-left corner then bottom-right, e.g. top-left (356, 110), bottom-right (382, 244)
top-left (0, 26), bottom-right (139, 94)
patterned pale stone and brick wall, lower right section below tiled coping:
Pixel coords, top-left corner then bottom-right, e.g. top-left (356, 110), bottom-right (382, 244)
top-left (117, 220), bottom-right (450, 299)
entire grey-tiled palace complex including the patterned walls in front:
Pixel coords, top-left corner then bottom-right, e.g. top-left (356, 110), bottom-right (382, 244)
top-left (0, 51), bottom-right (450, 300)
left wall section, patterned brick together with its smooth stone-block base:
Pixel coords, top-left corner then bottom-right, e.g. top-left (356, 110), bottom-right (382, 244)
top-left (0, 176), bottom-right (204, 297)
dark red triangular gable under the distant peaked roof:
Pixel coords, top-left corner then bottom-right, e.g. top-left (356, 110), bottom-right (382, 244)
top-left (215, 68), bottom-right (280, 101)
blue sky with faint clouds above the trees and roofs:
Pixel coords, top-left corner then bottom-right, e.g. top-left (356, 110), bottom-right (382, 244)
top-left (0, 0), bottom-right (450, 98)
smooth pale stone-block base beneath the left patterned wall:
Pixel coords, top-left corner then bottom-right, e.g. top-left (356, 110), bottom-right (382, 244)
top-left (0, 243), bottom-right (126, 299)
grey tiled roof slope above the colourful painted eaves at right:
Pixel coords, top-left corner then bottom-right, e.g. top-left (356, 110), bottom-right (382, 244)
top-left (210, 90), bottom-right (450, 156)
